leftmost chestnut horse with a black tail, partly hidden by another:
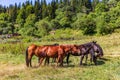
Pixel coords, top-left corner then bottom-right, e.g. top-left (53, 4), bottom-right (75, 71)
top-left (25, 44), bottom-right (48, 67)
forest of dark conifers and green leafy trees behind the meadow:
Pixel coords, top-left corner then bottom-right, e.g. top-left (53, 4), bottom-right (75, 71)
top-left (0, 0), bottom-right (120, 37)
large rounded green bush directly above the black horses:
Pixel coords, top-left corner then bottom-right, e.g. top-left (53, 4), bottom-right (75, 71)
top-left (73, 14), bottom-right (96, 34)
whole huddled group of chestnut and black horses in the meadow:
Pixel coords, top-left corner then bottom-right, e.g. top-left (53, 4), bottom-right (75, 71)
top-left (25, 41), bottom-right (103, 67)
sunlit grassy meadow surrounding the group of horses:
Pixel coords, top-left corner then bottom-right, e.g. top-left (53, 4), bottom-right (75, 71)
top-left (0, 33), bottom-right (120, 80)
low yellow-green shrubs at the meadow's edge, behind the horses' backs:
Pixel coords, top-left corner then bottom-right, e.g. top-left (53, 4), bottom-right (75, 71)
top-left (42, 28), bottom-right (83, 41)
